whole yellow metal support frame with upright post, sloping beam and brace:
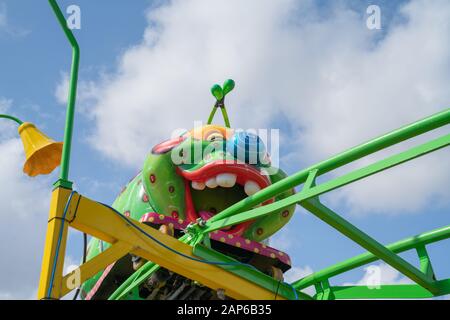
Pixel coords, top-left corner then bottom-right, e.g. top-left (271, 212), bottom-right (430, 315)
top-left (38, 188), bottom-right (285, 300)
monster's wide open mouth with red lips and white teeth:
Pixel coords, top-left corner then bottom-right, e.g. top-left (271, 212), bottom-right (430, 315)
top-left (177, 160), bottom-right (273, 235)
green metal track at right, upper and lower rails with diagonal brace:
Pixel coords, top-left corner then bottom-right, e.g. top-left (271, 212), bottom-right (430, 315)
top-left (193, 109), bottom-right (450, 299)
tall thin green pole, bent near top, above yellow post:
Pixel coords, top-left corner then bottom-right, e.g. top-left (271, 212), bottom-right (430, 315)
top-left (48, 0), bottom-right (80, 189)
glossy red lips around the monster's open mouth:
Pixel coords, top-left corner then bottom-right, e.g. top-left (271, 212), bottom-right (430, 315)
top-left (176, 160), bottom-right (274, 236)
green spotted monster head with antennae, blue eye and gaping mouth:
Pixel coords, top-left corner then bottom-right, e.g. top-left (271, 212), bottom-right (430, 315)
top-left (142, 80), bottom-right (295, 241)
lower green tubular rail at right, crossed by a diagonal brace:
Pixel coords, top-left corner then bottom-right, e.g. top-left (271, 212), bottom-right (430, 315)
top-left (292, 225), bottom-right (450, 290)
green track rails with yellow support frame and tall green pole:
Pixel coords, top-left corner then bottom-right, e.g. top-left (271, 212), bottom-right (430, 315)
top-left (0, 0), bottom-right (450, 300)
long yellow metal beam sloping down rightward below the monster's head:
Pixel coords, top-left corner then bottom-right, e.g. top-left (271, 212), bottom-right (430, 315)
top-left (71, 197), bottom-right (285, 300)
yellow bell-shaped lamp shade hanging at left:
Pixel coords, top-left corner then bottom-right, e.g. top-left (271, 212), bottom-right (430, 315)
top-left (19, 122), bottom-right (63, 177)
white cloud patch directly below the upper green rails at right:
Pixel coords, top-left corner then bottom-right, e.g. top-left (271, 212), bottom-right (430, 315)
top-left (331, 150), bottom-right (450, 216)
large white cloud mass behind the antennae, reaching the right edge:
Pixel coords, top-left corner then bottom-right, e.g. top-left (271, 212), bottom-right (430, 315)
top-left (81, 0), bottom-right (450, 213)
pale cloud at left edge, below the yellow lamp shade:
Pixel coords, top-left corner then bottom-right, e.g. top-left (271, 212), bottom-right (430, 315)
top-left (0, 102), bottom-right (51, 299)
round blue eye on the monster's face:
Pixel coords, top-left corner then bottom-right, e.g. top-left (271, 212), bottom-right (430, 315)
top-left (227, 131), bottom-right (266, 164)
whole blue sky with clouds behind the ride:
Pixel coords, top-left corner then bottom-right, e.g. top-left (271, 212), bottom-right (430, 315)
top-left (0, 0), bottom-right (450, 298)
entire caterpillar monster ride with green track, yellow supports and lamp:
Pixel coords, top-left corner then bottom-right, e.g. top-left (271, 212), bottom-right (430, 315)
top-left (0, 0), bottom-right (450, 300)
